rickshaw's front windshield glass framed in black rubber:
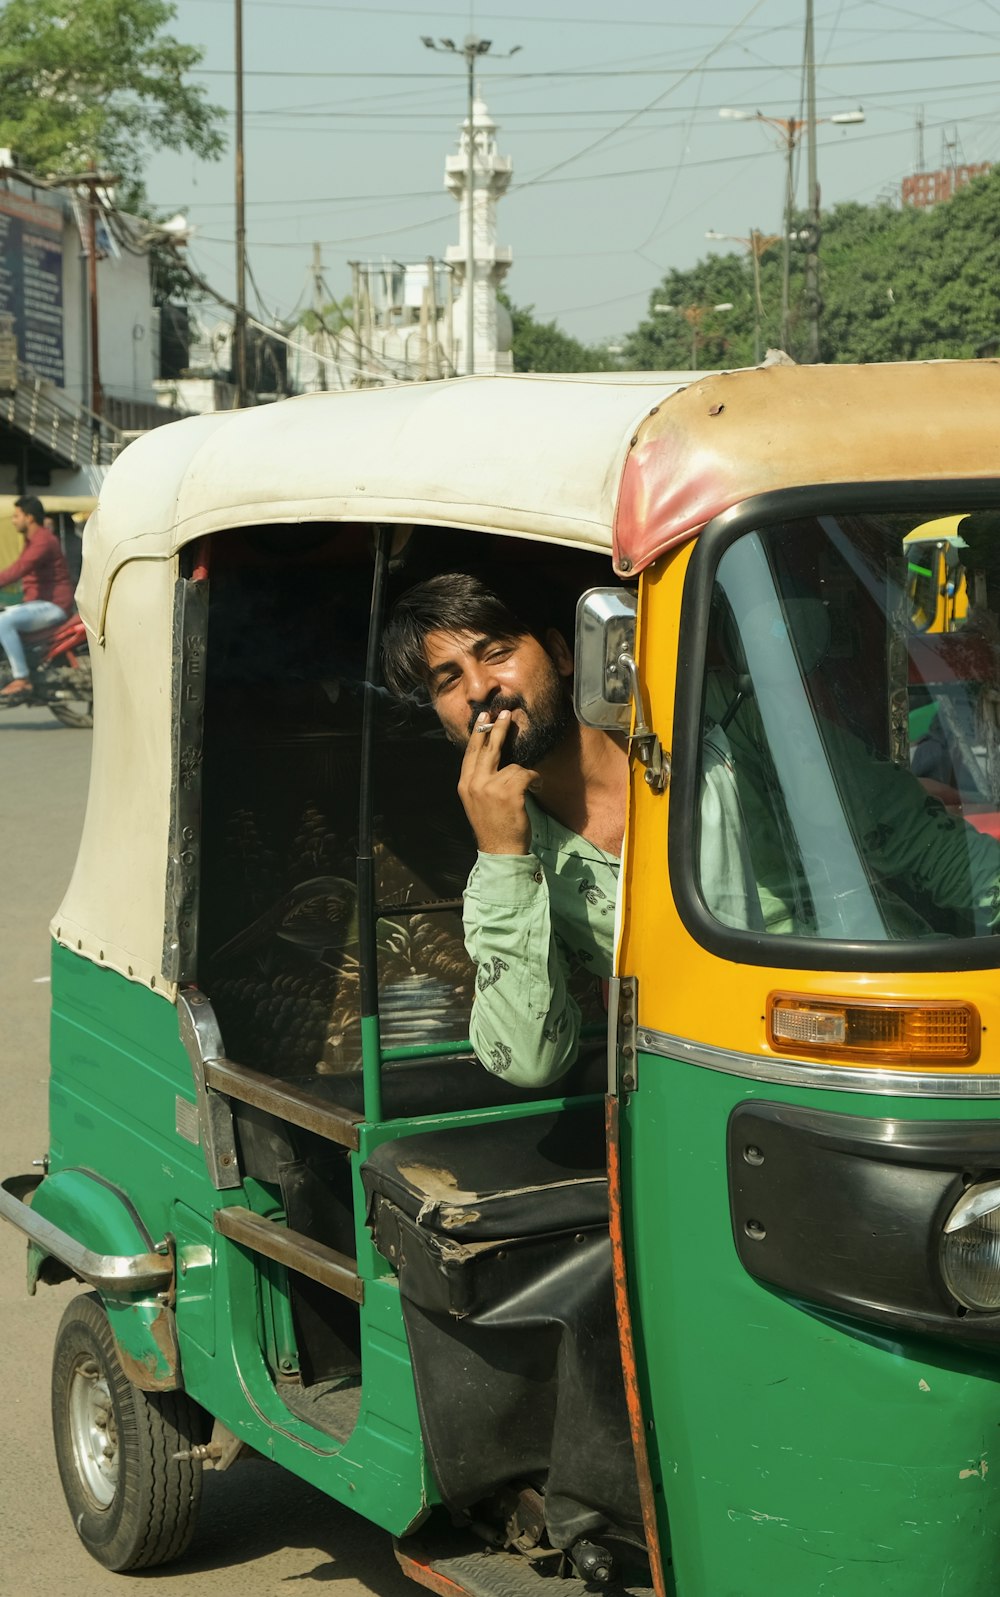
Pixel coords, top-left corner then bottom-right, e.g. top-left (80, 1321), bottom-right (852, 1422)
top-left (696, 514), bottom-right (1000, 942)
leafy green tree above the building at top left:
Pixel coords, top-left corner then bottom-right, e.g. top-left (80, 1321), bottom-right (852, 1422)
top-left (0, 0), bottom-right (225, 209)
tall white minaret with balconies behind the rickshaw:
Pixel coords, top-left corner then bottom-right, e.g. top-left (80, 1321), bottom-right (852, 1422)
top-left (444, 99), bottom-right (513, 374)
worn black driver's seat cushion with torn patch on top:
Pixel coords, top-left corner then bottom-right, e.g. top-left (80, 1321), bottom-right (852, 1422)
top-left (361, 1104), bottom-right (607, 1242)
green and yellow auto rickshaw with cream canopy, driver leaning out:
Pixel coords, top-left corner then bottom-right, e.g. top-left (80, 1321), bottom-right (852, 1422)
top-left (0, 361), bottom-right (1000, 1597)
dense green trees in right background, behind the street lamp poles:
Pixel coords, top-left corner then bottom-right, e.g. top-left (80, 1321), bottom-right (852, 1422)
top-left (625, 168), bottom-right (1000, 371)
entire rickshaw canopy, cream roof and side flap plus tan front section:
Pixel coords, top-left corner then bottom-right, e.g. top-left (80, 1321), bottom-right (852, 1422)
top-left (62, 361), bottom-right (1000, 997)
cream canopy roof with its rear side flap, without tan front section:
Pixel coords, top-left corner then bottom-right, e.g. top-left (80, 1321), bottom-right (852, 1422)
top-left (53, 374), bottom-right (690, 998)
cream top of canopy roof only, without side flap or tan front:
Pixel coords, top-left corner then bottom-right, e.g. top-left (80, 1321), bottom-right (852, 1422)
top-left (77, 372), bottom-right (692, 634)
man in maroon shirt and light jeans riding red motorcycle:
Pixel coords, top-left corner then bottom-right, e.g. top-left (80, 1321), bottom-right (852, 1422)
top-left (0, 495), bottom-right (73, 704)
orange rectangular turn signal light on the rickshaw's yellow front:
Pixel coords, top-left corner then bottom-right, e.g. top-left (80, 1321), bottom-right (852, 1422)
top-left (767, 993), bottom-right (979, 1067)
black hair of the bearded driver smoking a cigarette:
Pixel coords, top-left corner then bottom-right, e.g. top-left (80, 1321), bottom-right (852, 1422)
top-left (382, 572), bottom-right (561, 698)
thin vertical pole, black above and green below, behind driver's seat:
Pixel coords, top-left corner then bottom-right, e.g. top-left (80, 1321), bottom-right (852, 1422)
top-left (358, 527), bottom-right (391, 1123)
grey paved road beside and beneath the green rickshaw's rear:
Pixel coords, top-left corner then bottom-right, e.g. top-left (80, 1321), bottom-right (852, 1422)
top-left (0, 709), bottom-right (415, 1597)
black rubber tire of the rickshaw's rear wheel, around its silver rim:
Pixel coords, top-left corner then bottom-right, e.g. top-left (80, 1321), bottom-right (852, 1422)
top-left (53, 1292), bottom-right (206, 1573)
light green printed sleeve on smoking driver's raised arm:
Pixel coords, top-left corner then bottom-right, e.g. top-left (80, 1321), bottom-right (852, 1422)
top-left (465, 854), bottom-right (580, 1088)
